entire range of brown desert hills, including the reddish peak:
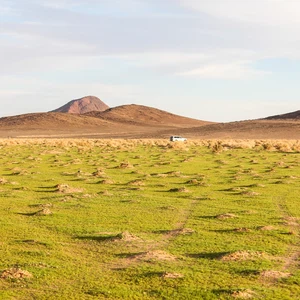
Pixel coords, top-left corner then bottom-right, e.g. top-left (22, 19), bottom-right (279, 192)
top-left (0, 96), bottom-right (300, 139)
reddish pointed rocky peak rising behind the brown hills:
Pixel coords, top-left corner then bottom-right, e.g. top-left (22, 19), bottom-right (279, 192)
top-left (52, 96), bottom-right (109, 114)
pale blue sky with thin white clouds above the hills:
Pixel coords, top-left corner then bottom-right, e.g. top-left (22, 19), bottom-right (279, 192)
top-left (0, 0), bottom-right (300, 122)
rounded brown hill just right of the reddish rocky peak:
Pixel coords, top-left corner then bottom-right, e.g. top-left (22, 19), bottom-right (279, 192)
top-left (85, 104), bottom-right (212, 127)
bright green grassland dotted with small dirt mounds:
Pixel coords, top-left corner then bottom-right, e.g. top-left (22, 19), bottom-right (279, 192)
top-left (0, 139), bottom-right (300, 299)
